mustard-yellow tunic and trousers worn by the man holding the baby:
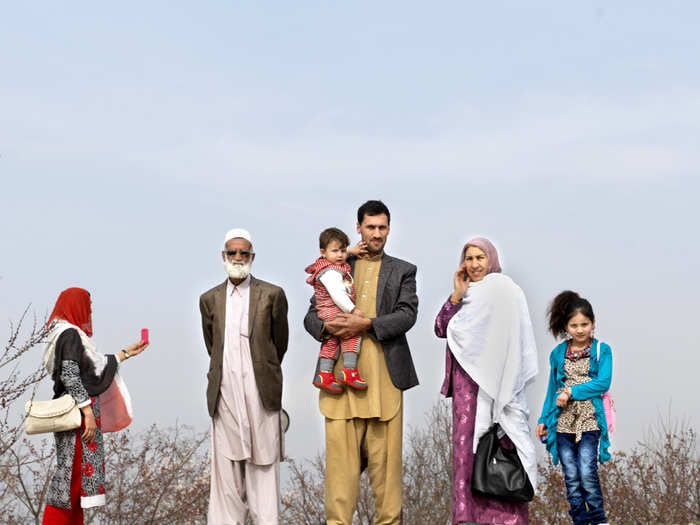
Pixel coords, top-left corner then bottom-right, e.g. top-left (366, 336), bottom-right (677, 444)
top-left (319, 255), bottom-right (403, 525)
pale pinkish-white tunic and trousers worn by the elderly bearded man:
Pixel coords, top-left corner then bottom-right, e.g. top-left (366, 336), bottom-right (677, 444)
top-left (207, 277), bottom-right (281, 525)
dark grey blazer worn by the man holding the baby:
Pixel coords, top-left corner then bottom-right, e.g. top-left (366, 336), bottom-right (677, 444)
top-left (304, 254), bottom-right (418, 390)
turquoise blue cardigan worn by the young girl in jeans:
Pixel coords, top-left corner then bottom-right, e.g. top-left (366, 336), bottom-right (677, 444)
top-left (537, 339), bottom-right (612, 465)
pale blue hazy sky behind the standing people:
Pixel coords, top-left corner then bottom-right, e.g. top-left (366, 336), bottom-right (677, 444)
top-left (0, 1), bottom-right (700, 472)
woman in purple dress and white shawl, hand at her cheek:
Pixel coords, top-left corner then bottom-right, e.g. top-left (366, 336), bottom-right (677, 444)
top-left (435, 237), bottom-right (537, 525)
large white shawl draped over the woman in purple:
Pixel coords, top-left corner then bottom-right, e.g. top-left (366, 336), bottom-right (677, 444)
top-left (447, 273), bottom-right (537, 489)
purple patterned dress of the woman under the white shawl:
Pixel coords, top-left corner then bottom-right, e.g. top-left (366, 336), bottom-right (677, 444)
top-left (435, 299), bottom-right (528, 525)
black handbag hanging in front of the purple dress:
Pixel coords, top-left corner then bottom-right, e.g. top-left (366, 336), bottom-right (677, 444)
top-left (472, 423), bottom-right (535, 502)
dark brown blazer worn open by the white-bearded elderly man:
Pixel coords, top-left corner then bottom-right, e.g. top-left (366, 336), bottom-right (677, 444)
top-left (199, 276), bottom-right (289, 417)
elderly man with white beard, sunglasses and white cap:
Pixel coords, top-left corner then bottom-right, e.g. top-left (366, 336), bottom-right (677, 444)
top-left (199, 228), bottom-right (289, 525)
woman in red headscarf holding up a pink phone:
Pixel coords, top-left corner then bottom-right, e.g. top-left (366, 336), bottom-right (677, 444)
top-left (43, 288), bottom-right (148, 525)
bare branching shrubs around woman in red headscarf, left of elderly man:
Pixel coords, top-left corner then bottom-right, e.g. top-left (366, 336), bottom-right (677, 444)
top-left (0, 307), bottom-right (209, 525)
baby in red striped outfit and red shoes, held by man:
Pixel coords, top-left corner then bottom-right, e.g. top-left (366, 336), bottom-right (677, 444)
top-left (306, 228), bottom-right (367, 394)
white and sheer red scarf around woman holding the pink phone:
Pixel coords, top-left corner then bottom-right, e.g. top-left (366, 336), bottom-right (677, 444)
top-left (44, 319), bottom-right (132, 432)
